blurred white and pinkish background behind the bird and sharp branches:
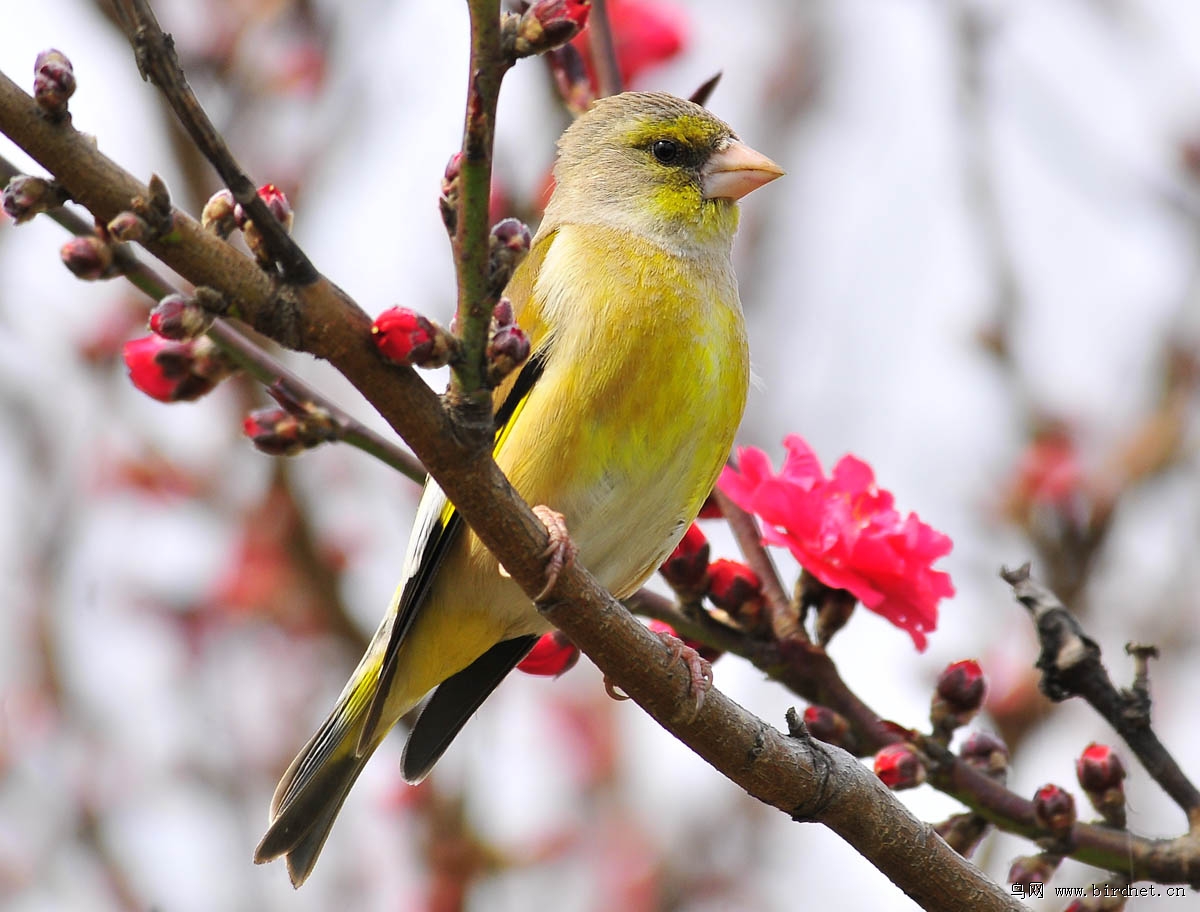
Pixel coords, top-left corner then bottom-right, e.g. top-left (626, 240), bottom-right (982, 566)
top-left (0, 0), bottom-right (1200, 912)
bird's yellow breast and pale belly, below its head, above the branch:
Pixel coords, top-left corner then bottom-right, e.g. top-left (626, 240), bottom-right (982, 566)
top-left (497, 224), bottom-right (749, 595)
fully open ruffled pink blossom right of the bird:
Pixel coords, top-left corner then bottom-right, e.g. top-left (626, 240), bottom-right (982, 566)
top-left (719, 434), bottom-right (954, 649)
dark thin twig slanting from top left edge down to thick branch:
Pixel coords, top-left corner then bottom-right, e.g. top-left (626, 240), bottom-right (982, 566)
top-left (116, 0), bottom-right (318, 284)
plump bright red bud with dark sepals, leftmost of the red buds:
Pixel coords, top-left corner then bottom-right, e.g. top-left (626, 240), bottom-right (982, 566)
top-left (121, 336), bottom-right (235, 402)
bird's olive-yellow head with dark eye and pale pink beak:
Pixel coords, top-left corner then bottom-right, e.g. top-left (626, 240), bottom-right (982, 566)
top-left (544, 92), bottom-right (784, 253)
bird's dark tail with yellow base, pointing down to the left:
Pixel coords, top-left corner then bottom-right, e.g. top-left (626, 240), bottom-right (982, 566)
top-left (254, 666), bottom-right (391, 887)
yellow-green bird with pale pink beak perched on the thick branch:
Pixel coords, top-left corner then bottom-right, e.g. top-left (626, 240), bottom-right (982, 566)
top-left (254, 92), bottom-right (784, 887)
